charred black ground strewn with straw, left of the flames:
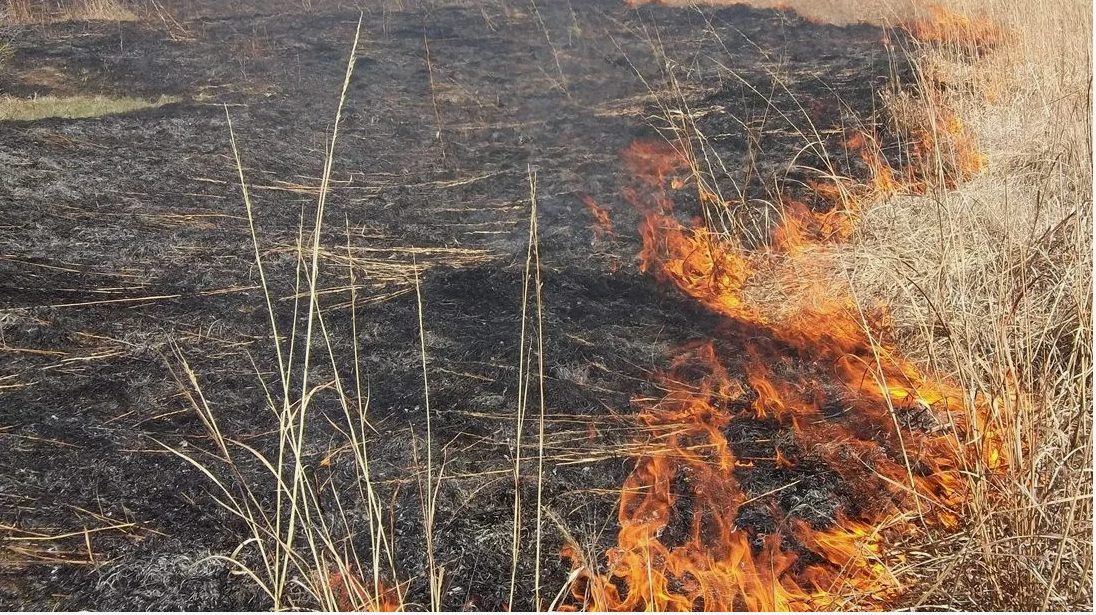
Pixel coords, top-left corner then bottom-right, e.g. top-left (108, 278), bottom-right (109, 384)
top-left (0, 0), bottom-right (903, 611)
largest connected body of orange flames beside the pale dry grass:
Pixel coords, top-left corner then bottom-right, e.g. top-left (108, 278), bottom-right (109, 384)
top-left (564, 135), bottom-right (1005, 611)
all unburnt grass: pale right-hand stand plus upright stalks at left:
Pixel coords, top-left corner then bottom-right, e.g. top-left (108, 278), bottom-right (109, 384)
top-left (0, 0), bottom-right (1093, 611)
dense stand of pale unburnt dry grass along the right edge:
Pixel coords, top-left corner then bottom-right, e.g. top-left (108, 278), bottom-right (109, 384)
top-left (842, 0), bottom-right (1093, 611)
